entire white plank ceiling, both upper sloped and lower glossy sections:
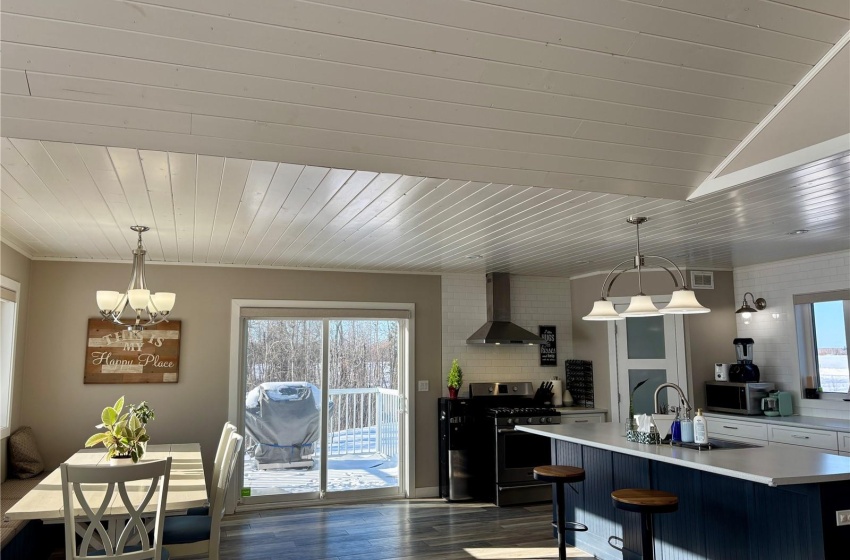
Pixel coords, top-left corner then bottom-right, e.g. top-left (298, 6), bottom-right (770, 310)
top-left (0, 0), bottom-right (850, 275)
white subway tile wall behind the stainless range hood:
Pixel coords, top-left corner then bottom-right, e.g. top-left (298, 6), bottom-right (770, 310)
top-left (442, 274), bottom-right (573, 395)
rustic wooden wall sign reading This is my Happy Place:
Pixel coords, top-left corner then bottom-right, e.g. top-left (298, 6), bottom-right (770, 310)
top-left (84, 318), bottom-right (180, 383)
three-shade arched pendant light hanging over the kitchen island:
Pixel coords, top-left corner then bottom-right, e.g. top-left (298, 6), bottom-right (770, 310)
top-left (582, 216), bottom-right (711, 321)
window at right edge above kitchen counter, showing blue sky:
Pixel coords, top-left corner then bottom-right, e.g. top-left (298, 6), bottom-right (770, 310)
top-left (794, 290), bottom-right (850, 397)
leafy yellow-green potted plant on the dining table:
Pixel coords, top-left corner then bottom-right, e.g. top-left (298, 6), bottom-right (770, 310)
top-left (86, 396), bottom-right (154, 465)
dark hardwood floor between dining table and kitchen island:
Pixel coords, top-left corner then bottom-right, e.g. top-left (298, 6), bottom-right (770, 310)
top-left (215, 500), bottom-right (593, 560)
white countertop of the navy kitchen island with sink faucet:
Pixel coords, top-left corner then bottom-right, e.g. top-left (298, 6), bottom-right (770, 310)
top-left (516, 422), bottom-right (850, 486)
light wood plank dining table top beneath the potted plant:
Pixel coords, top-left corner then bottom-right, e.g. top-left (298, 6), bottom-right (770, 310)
top-left (6, 443), bottom-right (207, 544)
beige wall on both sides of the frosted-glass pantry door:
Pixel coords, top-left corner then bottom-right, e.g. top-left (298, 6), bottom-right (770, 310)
top-left (570, 271), bottom-right (736, 418)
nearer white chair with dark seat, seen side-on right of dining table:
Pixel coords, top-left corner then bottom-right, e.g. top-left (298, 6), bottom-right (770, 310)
top-left (162, 433), bottom-right (242, 560)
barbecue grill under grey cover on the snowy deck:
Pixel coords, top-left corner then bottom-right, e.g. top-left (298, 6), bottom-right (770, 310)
top-left (245, 381), bottom-right (333, 469)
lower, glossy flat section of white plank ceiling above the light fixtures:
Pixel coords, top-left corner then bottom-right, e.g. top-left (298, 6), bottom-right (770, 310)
top-left (0, 138), bottom-right (850, 276)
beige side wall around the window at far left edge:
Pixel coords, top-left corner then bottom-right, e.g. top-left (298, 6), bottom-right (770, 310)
top-left (0, 243), bottom-right (30, 480)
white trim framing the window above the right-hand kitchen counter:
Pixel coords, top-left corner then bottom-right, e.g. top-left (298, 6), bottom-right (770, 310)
top-left (793, 290), bottom-right (850, 401)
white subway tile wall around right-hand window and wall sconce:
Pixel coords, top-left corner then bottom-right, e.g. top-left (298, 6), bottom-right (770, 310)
top-left (730, 251), bottom-right (850, 419)
